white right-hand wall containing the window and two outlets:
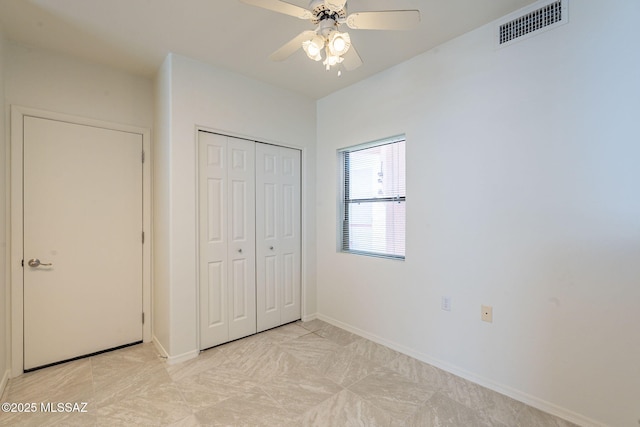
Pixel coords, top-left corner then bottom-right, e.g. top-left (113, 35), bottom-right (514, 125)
top-left (317, 0), bottom-right (640, 426)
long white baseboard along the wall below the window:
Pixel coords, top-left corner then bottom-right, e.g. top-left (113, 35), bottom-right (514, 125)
top-left (314, 314), bottom-right (607, 427)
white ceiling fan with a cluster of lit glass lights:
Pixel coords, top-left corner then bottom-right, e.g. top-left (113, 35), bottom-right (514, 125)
top-left (240, 0), bottom-right (420, 75)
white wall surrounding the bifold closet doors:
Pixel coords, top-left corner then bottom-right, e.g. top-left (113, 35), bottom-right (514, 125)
top-left (155, 54), bottom-right (316, 359)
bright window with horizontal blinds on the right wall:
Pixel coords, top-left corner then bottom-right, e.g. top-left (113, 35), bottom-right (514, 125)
top-left (338, 137), bottom-right (406, 259)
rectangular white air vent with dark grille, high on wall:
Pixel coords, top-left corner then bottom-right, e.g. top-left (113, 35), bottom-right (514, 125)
top-left (498, 0), bottom-right (567, 45)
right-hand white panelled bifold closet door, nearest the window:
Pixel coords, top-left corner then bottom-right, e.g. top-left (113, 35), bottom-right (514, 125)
top-left (256, 144), bottom-right (301, 332)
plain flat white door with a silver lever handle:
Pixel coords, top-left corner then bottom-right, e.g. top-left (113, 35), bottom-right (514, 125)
top-left (23, 117), bottom-right (143, 370)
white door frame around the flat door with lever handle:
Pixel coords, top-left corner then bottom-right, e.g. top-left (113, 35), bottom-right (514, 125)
top-left (8, 105), bottom-right (153, 377)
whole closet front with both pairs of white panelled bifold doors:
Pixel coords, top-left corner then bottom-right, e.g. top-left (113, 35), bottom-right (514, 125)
top-left (198, 131), bottom-right (301, 349)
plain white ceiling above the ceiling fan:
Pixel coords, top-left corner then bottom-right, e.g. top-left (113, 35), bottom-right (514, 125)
top-left (0, 0), bottom-right (534, 99)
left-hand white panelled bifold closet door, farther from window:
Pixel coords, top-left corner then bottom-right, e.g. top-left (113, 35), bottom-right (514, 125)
top-left (199, 132), bottom-right (256, 349)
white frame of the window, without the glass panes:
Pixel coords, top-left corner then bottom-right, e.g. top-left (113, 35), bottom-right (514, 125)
top-left (337, 134), bottom-right (407, 261)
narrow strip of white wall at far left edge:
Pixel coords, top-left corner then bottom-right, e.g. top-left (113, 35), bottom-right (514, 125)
top-left (0, 28), bottom-right (11, 394)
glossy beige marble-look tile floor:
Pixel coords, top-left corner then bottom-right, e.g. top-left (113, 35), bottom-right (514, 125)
top-left (0, 320), bottom-right (573, 427)
